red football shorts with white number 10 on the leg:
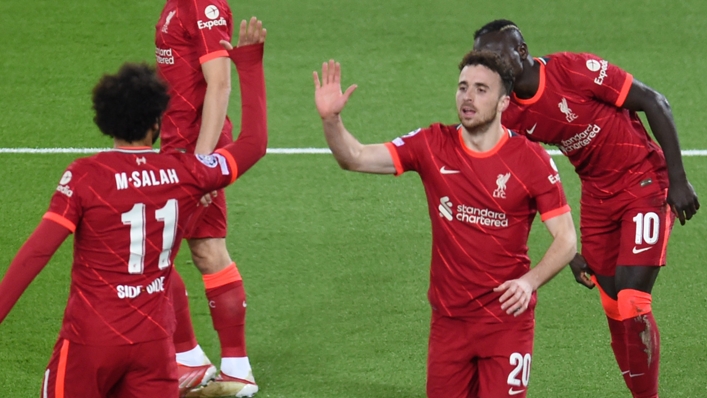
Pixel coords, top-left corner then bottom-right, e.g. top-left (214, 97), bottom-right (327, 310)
top-left (580, 187), bottom-right (675, 276)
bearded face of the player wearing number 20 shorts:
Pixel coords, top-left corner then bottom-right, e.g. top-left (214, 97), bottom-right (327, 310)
top-left (457, 65), bottom-right (508, 132)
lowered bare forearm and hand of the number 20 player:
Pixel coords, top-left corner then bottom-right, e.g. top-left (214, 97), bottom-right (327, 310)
top-left (494, 212), bottom-right (577, 316)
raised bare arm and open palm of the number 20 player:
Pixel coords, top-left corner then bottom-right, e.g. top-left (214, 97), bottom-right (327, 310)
top-left (313, 60), bottom-right (395, 174)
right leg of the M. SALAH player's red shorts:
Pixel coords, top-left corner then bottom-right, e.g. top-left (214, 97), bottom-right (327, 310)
top-left (109, 339), bottom-right (179, 398)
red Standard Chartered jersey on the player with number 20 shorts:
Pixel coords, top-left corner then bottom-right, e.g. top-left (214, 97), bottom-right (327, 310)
top-left (386, 124), bottom-right (570, 322)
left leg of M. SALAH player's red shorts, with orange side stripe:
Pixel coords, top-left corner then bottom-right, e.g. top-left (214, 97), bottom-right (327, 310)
top-left (41, 339), bottom-right (123, 398)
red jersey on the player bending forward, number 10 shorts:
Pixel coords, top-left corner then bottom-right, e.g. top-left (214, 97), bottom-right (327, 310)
top-left (502, 53), bottom-right (668, 199)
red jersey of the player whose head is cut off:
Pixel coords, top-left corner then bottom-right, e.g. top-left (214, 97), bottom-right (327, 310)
top-left (155, 0), bottom-right (233, 152)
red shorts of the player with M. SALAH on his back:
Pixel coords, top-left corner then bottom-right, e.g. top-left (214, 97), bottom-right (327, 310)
top-left (41, 338), bottom-right (179, 398)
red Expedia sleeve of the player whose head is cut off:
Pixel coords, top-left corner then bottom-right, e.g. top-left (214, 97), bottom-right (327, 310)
top-left (187, 0), bottom-right (233, 64)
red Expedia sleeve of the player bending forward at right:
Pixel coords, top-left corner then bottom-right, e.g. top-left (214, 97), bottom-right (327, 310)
top-left (567, 53), bottom-right (633, 107)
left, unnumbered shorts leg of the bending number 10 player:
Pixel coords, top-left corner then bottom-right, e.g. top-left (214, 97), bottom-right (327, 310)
top-left (579, 200), bottom-right (621, 276)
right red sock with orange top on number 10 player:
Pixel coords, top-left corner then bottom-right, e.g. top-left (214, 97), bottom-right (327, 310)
top-left (619, 289), bottom-right (660, 398)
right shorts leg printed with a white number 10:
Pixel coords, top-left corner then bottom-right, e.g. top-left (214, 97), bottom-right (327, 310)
top-left (618, 194), bottom-right (675, 266)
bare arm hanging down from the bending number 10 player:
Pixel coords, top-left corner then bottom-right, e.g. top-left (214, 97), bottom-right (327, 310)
top-left (623, 79), bottom-right (700, 225)
